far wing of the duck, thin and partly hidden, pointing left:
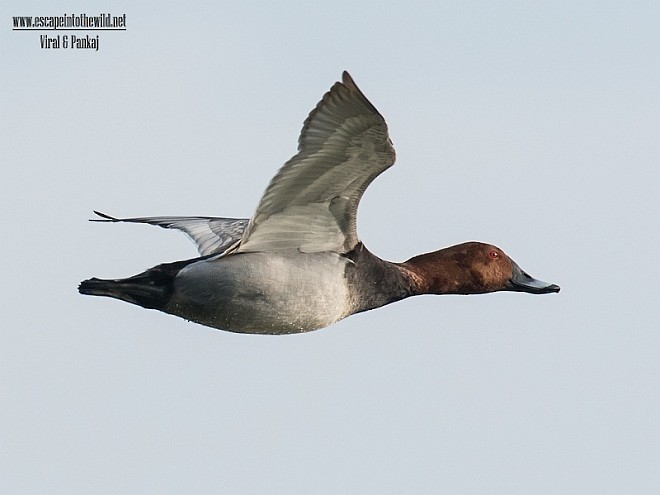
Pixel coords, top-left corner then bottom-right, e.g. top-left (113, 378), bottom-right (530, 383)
top-left (92, 211), bottom-right (248, 256)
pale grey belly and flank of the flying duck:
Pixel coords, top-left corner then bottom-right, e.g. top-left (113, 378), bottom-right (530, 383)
top-left (167, 252), bottom-right (352, 334)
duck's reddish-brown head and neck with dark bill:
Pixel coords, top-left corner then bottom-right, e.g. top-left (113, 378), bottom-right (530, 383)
top-left (401, 242), bottom-right (559, 294)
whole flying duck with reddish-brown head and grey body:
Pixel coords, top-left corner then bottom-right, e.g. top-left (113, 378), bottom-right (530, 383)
top-left (79, 72), bottom-right (559, 334)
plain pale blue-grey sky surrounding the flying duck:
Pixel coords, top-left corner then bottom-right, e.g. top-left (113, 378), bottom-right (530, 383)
top-left (0, 0), bottom-right (660, 494)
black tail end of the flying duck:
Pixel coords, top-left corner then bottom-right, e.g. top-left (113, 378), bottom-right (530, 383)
top-left (78, 258), bottom-right (199, 311)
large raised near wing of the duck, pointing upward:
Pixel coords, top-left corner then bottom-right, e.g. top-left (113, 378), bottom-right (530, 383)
top-left (238, 72), bottom-right (395, 253)
